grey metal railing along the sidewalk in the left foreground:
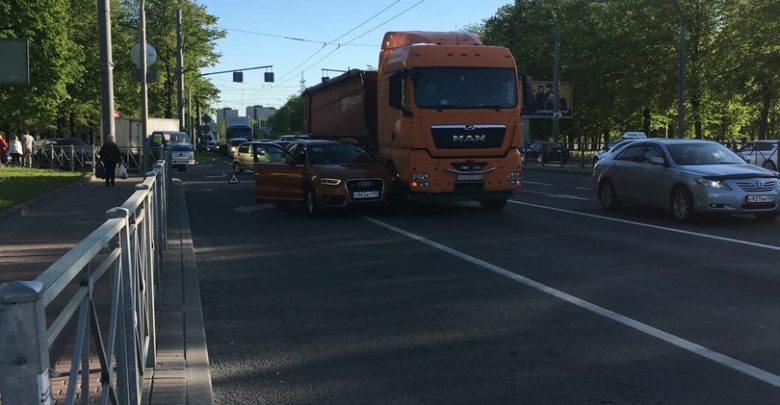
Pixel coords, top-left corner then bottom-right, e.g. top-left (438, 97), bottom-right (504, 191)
top-left (0, 161), bottom-right (170, 405)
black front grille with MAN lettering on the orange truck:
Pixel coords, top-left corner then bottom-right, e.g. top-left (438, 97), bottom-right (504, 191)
top-left (431, 125), bottom-right (506, 149)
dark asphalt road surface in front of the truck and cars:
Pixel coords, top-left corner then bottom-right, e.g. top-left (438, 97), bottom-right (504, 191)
top-left (176, 155), bottom-right (780, 404)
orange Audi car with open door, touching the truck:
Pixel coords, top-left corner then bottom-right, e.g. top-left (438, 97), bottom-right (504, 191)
top-left (255, 139), bottom-right (395, 214)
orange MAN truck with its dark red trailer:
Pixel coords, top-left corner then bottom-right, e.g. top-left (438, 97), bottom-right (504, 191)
top-left (303, 31), bottom-right (531, 209)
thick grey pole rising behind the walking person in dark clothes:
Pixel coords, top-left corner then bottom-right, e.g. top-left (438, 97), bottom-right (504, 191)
top-left (97, 0), bottom-right (115, 143)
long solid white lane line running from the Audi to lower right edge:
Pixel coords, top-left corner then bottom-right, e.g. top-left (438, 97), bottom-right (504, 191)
top-left (363, 216), bottom-right (780, 388)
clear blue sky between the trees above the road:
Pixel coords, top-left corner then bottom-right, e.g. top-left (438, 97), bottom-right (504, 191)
top-left (195, 0), bottom-right (513, 115)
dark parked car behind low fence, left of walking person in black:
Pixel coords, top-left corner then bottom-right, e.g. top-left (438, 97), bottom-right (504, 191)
top-left (33, 138), bottom-right (98, 168)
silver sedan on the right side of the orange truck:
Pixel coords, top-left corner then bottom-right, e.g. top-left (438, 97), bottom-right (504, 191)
top-left (593, 139), bottom-right (780, 221)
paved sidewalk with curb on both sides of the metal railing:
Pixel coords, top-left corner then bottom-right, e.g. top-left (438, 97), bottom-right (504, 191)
top-left (0, 178), bottom-right (212, 405)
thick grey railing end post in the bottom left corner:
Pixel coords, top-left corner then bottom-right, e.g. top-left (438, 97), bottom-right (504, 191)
top-left (0, 281), bottom-right (51, 405)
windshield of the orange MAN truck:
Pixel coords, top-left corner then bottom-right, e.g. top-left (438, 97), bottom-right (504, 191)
top-left (411, 67), bottom-right (517, 109)
